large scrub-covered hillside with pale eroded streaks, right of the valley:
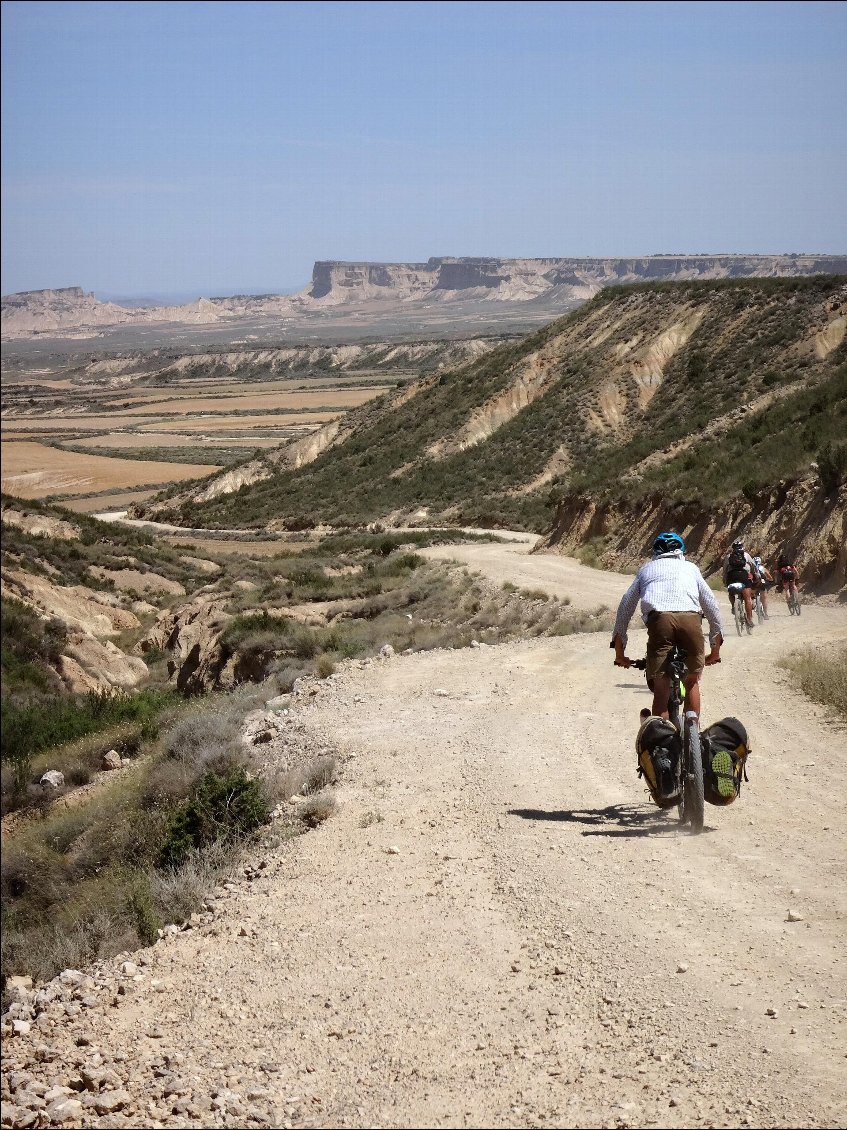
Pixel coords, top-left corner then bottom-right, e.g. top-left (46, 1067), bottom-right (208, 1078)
top-left (137, 276), bottom-right (847, 588)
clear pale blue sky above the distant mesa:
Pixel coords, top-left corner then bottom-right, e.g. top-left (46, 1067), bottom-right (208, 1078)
top-left (2, 0), bottom-right (847, 296)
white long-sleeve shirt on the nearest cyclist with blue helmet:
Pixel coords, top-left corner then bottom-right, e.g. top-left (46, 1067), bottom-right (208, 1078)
top-left (614, 550), bottom-right (724, 647)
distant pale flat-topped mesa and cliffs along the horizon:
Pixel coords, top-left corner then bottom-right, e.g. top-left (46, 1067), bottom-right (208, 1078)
top-left (2, 254), bottom-right (847, 340)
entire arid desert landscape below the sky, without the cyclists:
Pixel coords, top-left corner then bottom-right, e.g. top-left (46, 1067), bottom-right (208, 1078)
top-left (1, 255), bottom-right (847, 1130)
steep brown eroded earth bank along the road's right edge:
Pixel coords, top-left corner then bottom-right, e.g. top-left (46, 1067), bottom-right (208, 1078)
top-left (536, 471), bottom-right (847, 600)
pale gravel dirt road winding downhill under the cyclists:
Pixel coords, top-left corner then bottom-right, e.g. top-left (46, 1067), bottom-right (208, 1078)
top-left (3, 546), bottom-right (847, 1128)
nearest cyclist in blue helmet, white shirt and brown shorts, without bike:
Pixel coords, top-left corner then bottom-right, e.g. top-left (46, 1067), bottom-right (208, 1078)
top-left (612, 532), bottom-right (724, 718)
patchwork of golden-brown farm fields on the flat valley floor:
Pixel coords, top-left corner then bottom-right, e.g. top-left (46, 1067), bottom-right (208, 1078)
top-left (2, 357), bottom-right (395, 512)
